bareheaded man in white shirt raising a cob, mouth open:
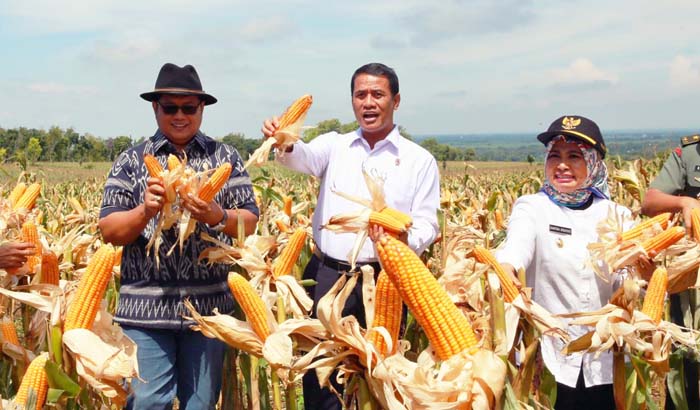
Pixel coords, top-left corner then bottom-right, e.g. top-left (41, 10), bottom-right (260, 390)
top-left (262, 63), bottom-right (440, 409)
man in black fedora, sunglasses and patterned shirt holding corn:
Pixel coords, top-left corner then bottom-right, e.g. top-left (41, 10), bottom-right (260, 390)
top-left (99, 63), bottom-right (259, 409)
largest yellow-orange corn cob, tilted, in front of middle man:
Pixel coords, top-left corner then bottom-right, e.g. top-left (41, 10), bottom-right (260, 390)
top-left (376, 235), bottom-right (477, 360)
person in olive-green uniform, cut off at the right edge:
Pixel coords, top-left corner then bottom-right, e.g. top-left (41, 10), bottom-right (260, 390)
top-left (642, 135), bottom-right (700, 409)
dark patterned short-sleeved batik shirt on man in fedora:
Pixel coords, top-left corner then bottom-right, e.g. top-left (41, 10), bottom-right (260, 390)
top-left (100, 132), bottom-right (259, 329)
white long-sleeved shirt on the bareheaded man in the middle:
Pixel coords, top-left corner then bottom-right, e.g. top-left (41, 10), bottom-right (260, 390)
top-left (277, 127), bottom-right (440, 262)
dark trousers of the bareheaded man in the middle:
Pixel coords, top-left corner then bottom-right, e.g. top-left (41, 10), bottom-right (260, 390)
top-left (303, 255), bottom-right (379, 410)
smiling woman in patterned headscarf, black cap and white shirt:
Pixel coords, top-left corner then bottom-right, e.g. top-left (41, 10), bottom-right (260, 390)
top-left (496, 115), bottom-right (631, 410)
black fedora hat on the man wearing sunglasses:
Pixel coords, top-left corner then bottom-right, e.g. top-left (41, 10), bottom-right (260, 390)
top-left (141, 63), bottom-right (217, 105)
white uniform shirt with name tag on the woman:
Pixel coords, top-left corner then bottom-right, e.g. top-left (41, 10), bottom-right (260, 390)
top-left (496, 192), bottom-right (631, 387)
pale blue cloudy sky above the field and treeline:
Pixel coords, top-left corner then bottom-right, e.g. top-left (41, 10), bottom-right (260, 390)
top-left (0, 0), bottom-right (700, 137)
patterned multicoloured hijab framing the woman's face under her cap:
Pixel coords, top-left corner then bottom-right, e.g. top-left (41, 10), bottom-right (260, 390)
top-left (541, 135), bottom-right (610, 208)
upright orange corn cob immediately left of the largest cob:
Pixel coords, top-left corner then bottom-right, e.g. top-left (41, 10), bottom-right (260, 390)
top-left (367, 271), bottom-right (403, 357)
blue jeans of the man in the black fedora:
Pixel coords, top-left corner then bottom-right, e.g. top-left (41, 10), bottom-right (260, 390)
top-left (122, 326), bottom-right (225, 410)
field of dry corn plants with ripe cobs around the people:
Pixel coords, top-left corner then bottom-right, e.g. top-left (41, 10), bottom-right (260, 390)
top-left (0, 157), bottom-right (700, 409)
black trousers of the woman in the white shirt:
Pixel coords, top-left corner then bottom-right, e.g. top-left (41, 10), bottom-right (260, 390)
top-left (554, 370), bottom-right (615, 410)
